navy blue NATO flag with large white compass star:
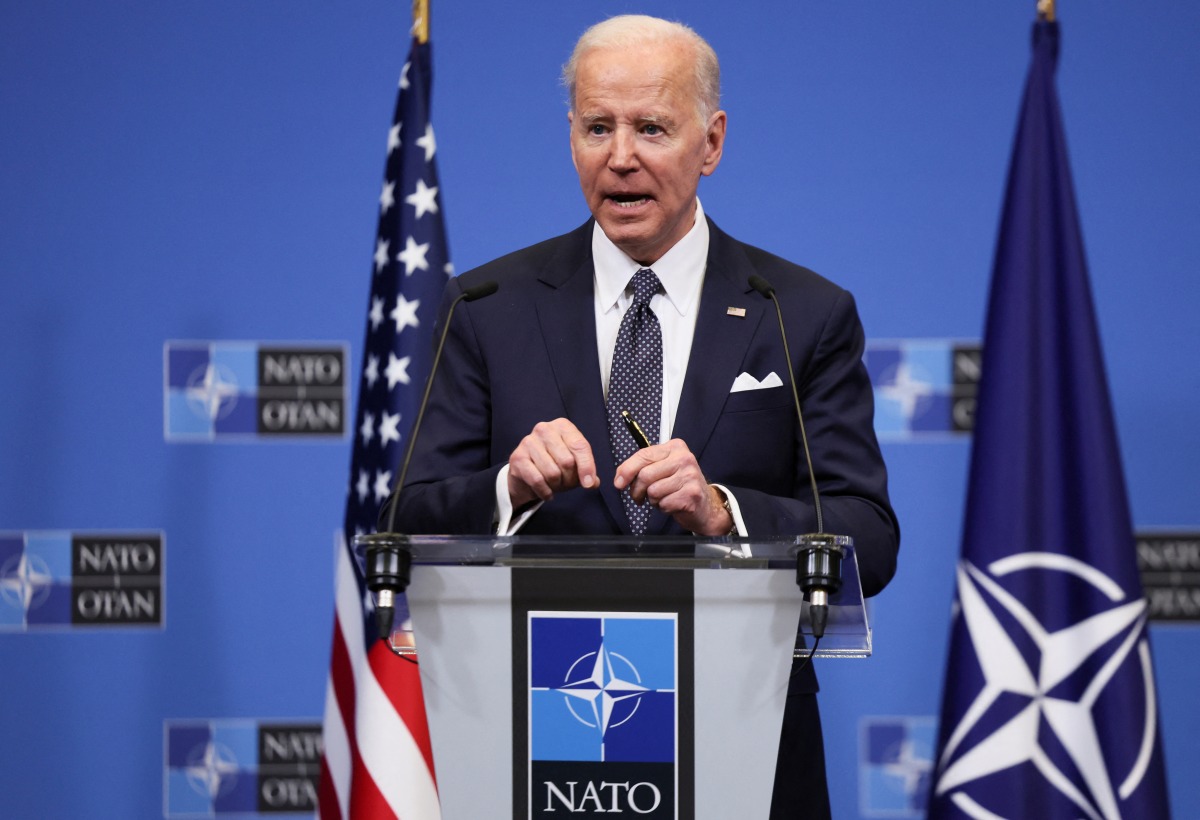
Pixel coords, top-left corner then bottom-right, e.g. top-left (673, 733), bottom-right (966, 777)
top-left (929, 20), bottom-right (1169, 820)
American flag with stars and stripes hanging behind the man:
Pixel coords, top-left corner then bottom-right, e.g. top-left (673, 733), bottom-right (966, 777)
top-left (319, 32), bottom-right (454, 820)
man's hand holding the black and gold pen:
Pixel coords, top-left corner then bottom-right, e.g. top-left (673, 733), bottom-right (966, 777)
top-left (614, 438), bottom-right (733, 535)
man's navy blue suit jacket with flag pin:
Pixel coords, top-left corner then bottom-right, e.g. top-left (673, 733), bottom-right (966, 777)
top-left (397, 220), bottom-right (899, 595)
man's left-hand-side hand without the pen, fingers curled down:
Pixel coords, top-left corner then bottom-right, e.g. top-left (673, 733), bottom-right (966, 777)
top-left (509, 419), bottom-right (600, 510)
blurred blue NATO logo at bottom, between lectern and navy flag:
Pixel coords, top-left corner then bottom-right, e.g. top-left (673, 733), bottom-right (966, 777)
top-left (858, 717), bottom-right (937, 820)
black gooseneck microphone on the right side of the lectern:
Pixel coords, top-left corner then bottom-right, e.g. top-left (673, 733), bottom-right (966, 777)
top-left (749, 274), bottom-right (853, 643)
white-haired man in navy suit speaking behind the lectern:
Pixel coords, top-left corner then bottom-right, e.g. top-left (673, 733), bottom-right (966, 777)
top-left (397, 16), bottom-right (899, 819)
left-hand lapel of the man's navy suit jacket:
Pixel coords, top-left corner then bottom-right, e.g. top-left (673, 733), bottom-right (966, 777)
top-left (538, 220), bottom-right (629, 533)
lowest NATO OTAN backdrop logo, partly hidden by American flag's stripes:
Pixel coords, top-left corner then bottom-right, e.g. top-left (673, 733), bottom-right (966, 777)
top-left (163, 719), bottom-right (322, 818)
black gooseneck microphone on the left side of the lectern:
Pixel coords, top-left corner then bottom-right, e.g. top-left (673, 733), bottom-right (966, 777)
top-left (362, 282), bottom-right (500, 640)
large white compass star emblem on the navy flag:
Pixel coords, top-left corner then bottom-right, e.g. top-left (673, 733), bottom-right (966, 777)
top-left (936, 552), bottom-right (1158, 820)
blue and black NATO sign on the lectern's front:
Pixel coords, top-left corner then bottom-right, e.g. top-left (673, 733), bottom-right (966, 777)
top-left (528, 611), bottom-right (679, 820)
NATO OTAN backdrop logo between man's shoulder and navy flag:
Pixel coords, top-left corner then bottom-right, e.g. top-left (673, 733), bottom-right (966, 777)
top-left (863, 339), bottom-right (983, 439)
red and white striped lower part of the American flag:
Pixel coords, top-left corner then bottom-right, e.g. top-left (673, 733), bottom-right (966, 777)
top-left (318, 549), bottom-right (442, 820)
